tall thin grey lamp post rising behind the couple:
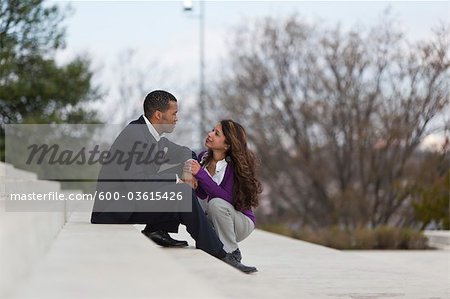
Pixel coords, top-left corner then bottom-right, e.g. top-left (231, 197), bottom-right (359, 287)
top-left (183, 0), bottom-right (207, 140)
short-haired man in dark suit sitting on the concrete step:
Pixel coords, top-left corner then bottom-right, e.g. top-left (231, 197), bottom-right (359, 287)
top-left (91, 90), bottom-right (257, 273)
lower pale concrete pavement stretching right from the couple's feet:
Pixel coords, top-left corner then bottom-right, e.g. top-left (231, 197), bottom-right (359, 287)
top-left (160, 227), bottom-right (450, 299)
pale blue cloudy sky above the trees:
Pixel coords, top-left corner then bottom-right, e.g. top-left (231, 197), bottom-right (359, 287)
top-left (50, 1), bottom-right (450, 138)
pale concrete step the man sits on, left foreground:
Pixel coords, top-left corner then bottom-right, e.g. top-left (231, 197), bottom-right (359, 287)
top-left (7, 213), bottom-right (229, 299)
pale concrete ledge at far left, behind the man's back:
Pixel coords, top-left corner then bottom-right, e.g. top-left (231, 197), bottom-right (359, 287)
top-left (0, 162), bottom-right (72, 298)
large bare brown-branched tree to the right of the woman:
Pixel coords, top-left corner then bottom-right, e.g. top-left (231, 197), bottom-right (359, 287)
top-left (212, 16), bottom-right (450, 228)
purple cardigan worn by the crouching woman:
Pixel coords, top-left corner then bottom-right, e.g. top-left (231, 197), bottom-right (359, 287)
top-left (195, 151), bottom-right (256, 225)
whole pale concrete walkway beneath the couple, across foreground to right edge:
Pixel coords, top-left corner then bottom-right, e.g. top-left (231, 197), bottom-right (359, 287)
top-left (4, 213), bottom-right (450, 299)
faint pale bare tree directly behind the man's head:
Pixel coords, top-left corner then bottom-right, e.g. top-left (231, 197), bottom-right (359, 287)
top-left (105, 49), bottom-right (200, 149)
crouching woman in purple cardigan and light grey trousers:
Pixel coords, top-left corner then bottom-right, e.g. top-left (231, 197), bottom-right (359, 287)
top-left (185, 120), bottom-right (262, 262)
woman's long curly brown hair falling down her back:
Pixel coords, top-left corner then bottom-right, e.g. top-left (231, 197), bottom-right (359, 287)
top-left (204, 119), bottom-right (262, 211)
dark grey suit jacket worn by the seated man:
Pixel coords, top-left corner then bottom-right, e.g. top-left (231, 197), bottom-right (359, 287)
top-left (91, 116), bottom-right (195, 224)
